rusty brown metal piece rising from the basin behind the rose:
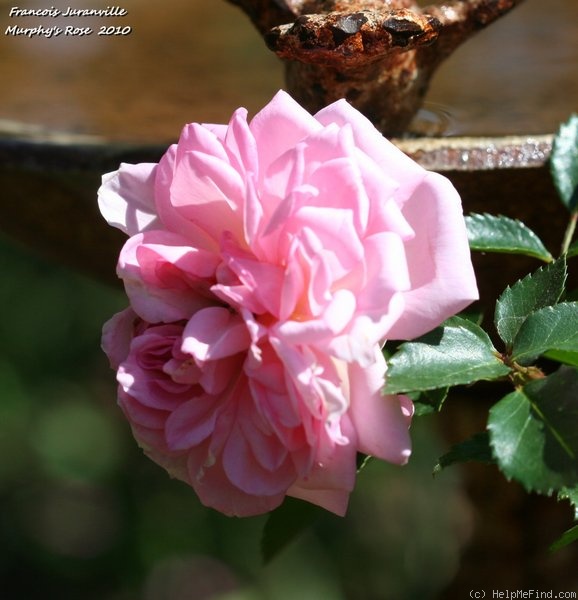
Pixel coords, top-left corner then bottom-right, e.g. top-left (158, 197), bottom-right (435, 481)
top-left (231, 0), bottom-right (523, 136)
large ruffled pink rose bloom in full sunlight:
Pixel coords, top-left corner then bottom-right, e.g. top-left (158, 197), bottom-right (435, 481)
top-left (99, 92), bottom-right (478, 516)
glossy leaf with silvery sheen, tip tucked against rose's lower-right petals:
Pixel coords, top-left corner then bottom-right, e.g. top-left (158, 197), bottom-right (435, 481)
top-left (385, 317), bottom-right (510, 394)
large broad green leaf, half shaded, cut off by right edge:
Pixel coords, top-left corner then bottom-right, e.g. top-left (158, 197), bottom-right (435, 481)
top-left (488, 367), bottom-right (578, 494)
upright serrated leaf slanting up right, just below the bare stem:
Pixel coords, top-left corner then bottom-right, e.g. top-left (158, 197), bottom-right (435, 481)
top-left (494, 258), bottom-right (567, 348)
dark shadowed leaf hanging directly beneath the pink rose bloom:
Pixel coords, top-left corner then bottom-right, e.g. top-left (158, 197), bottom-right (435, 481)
top-left (261, 497), bottom-right (325, 563)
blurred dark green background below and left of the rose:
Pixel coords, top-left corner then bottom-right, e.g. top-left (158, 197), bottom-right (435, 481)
top-left (0, 238), bottom-right (471, 600)
